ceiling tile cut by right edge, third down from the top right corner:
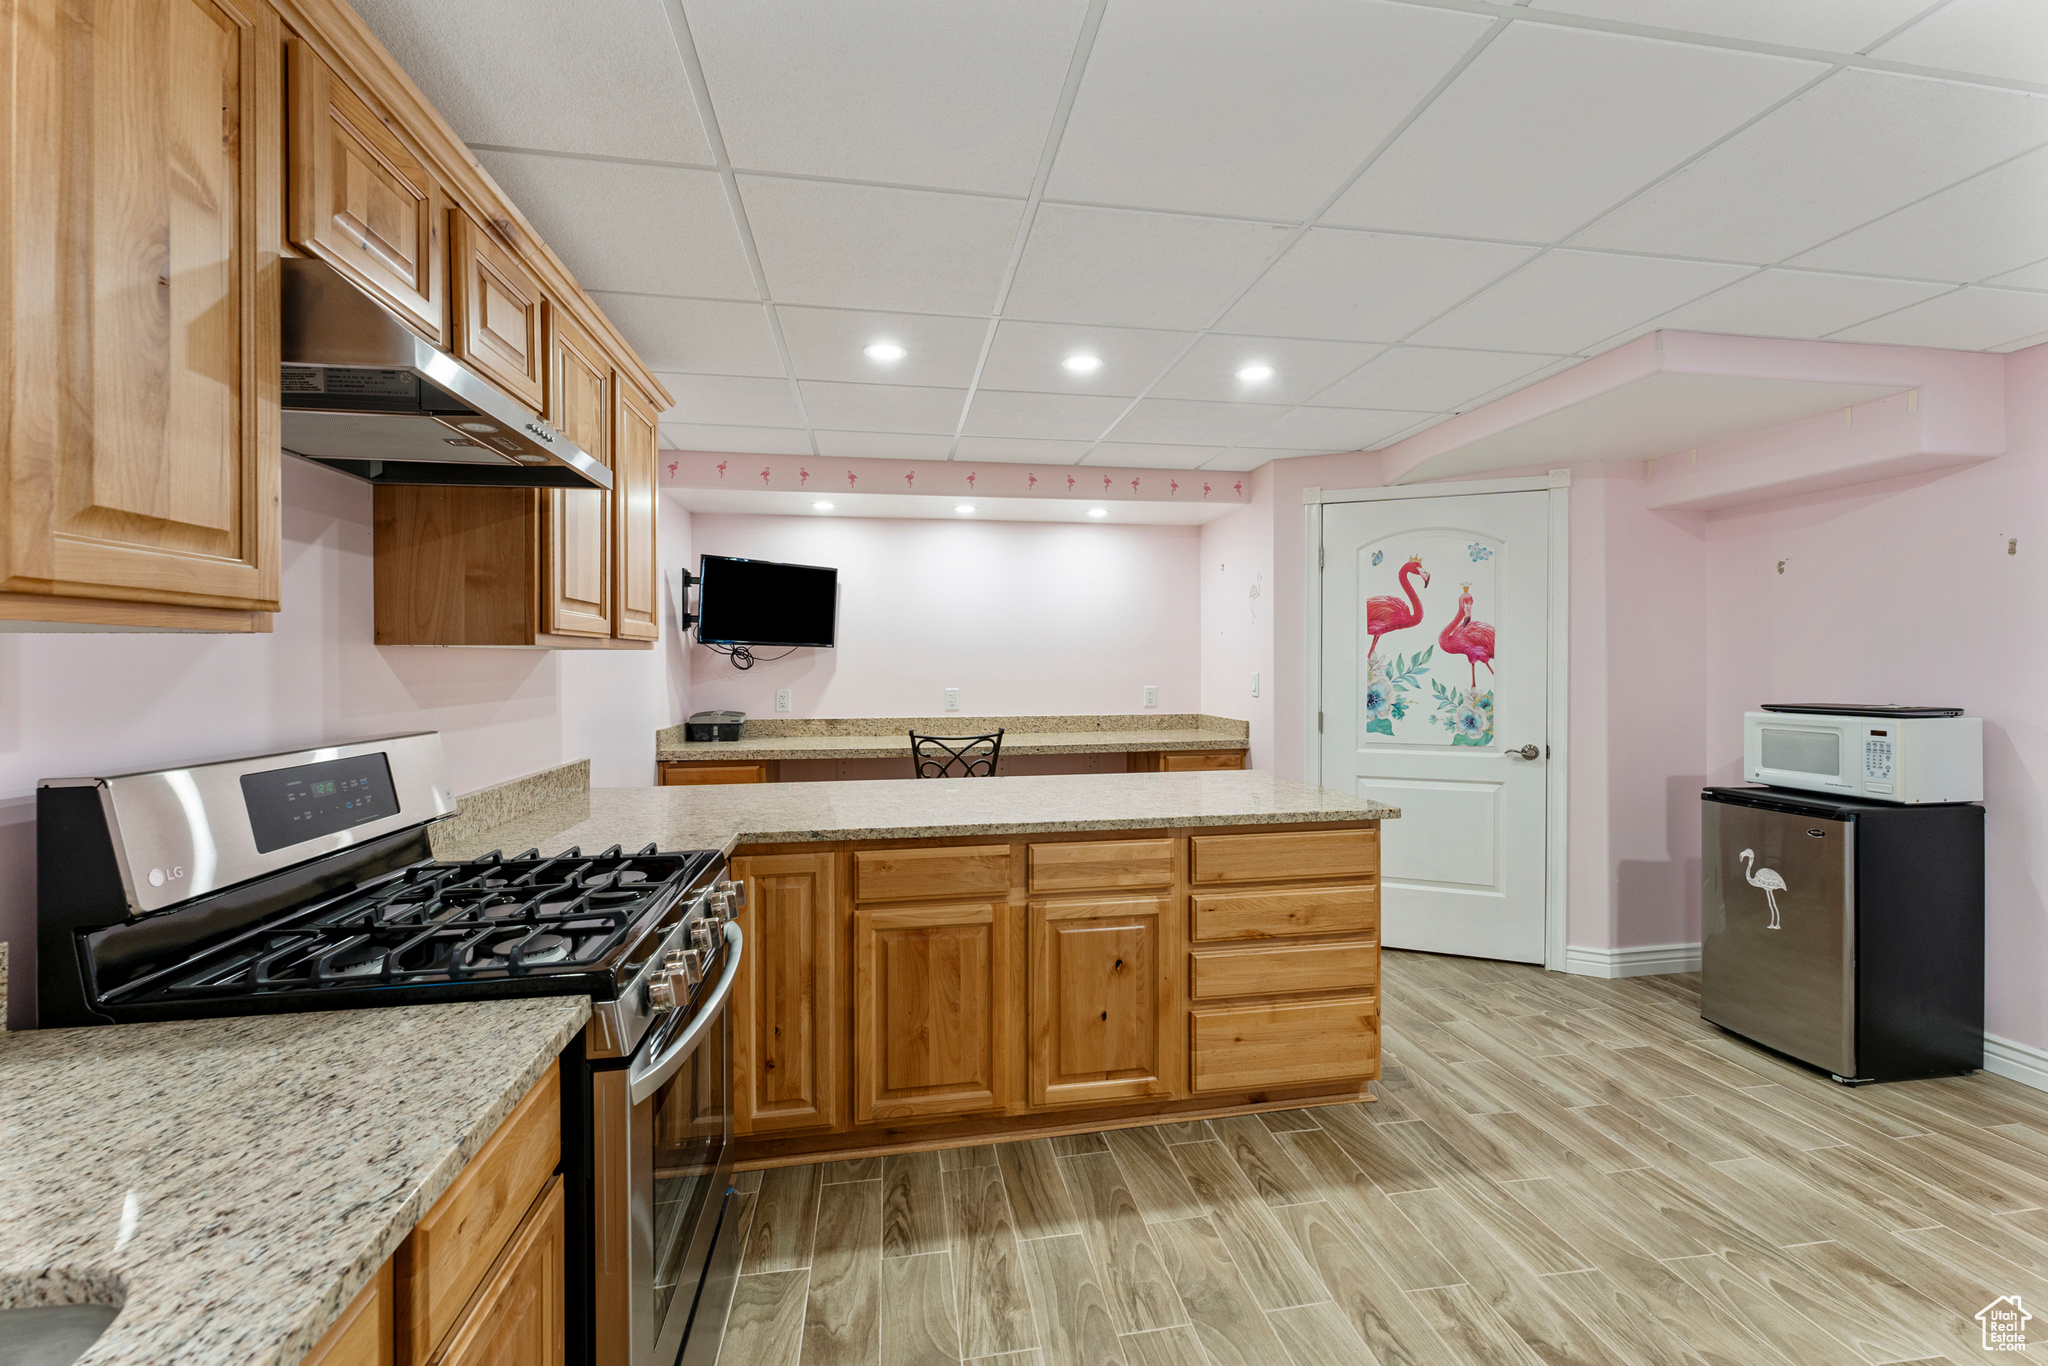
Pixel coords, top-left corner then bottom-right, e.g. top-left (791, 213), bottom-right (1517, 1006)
top-left (1794, 145), bottom-right (2048, 285)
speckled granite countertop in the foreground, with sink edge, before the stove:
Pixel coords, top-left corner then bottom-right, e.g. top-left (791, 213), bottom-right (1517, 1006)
top-left (0, 997), bottom-right (590, 1366)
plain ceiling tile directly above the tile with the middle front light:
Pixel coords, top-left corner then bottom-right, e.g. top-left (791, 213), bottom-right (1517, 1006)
top-left (1004, 205), bottom-right (1286, 328)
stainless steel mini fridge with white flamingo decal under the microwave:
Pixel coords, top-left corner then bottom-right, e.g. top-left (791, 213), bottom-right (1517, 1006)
top-left (1700, 786), bottom-right (1985, 1083)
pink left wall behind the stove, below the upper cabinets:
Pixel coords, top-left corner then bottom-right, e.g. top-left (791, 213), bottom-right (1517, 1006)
top-left (0, 459), bottom-right (686, 1026)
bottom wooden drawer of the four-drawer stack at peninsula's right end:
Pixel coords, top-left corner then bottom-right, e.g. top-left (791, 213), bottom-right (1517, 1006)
top-left (1188, 995), bottom-right (1380, 1092)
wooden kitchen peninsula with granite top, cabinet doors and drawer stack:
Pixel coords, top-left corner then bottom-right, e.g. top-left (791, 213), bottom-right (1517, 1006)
top-left (436, 772), bottom-right (1401, 1165)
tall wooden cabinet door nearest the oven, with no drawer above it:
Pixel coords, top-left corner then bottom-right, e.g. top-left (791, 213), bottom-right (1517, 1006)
top-left (731, 854), bottom-right (844, 1135)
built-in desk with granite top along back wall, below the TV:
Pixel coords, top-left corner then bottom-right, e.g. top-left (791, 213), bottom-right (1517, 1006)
top-left (655, 713), bottom-right (1251, 786)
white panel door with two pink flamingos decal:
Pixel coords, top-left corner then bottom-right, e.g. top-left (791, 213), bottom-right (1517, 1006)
top-left (1321, 492), bottom-right (1550, 963)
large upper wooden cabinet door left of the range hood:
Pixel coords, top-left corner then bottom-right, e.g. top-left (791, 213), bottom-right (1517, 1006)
top-left (0, 0), bottom-right (283, 610)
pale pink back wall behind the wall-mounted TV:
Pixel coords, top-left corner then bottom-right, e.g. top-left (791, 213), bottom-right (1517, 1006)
top-left (679, 511), bottom-right (1204, 717)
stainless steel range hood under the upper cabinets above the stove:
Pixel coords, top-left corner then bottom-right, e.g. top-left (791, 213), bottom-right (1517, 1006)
top-left (279, 258), bottom-right (612, 489)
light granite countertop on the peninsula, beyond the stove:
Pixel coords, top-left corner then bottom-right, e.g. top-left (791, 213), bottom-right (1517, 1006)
top-left (434, 770), bottom-right (1401, 858)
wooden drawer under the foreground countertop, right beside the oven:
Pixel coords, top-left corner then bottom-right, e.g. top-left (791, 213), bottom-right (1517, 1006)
top-left (393, 1067), bottom-right (561, 1366)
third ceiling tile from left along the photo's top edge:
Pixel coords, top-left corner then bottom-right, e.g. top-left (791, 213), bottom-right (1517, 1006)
top-left (1047, 0), bottom-right (1487, 221)
